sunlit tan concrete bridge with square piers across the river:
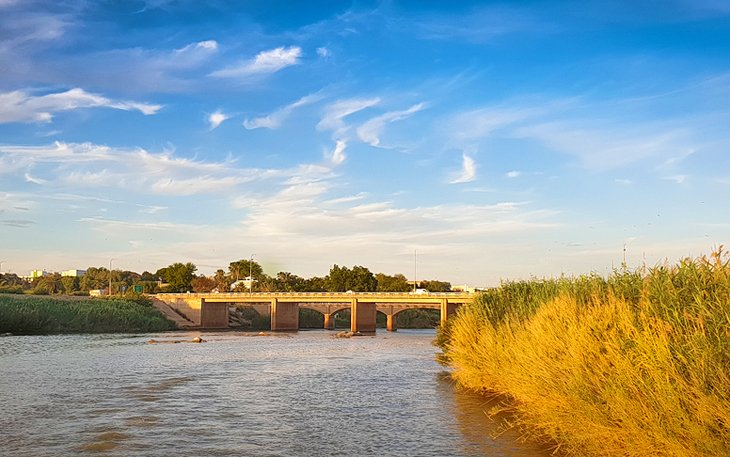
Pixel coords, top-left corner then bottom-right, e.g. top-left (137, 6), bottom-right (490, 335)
top-left (156, 292), bottom-right (473, 332)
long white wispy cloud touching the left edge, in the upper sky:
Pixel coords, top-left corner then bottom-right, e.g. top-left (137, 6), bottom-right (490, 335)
top-left (0, 88), bottom-right (162, 123)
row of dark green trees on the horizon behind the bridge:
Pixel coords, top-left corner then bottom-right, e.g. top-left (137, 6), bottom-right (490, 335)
top-left (0, 259), bottom-right (451, 295)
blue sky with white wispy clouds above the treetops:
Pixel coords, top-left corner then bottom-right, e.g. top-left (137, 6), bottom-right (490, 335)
top-left (0, 0), bottom-right (730, 285)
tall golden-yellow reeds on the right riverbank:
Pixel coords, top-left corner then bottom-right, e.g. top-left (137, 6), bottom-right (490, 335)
top-left (437, 249), bottom-right (730, 457)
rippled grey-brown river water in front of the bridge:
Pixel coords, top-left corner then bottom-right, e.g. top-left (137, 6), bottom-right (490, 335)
top-left (0, 330), bottom-right (549, 457)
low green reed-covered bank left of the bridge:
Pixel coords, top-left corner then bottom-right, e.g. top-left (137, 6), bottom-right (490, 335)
top-left (0, 295), bottom-right (177, 335)
